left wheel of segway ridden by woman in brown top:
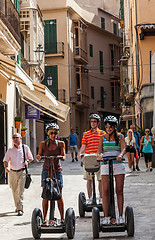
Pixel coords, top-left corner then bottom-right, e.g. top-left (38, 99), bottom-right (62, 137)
top-left (31, 208), bottom-right (43, 239)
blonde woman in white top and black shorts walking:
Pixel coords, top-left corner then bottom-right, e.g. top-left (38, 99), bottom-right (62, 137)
top-left (125, 129), bottom-right (137, 173)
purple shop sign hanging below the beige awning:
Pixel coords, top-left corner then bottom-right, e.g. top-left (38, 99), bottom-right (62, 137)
top-left (25, 104), bottom-right (40, 119)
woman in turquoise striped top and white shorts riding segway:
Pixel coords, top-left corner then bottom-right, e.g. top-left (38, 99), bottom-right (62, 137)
top-left (98, 116), bottom-right (125, 224)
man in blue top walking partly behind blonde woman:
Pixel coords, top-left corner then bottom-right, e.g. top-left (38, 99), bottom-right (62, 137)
top-left (130, 124), bottom-right (141, 171)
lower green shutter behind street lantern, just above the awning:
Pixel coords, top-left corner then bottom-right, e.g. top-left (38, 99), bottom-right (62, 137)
top-left (42, 66), bottom-right (58, 99)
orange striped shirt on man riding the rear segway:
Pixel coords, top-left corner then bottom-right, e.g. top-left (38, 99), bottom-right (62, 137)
top-left (82, 128), bottom-right (105, 154)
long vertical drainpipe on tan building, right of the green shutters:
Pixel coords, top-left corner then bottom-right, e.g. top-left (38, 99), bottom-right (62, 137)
top-left (67, 11), bottom-right (72, 129)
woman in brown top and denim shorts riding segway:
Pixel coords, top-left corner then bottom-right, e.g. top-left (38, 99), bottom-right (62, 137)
top-left (36, 123), bottom-right (65, 224)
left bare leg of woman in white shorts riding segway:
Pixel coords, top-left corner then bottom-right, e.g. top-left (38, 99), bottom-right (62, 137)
top-left (101, 175), bottom-right (109, 217)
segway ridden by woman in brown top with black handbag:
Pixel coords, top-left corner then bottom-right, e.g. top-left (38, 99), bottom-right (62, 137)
top-left (31, 156), bottom-right (75, 239)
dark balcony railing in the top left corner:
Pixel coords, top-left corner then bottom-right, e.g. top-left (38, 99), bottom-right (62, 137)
top-left (0, 0), bottom-right (20, 44)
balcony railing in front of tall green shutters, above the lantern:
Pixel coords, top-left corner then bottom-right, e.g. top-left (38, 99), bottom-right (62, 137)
top-left (45, 42), bottom-right (64, 56)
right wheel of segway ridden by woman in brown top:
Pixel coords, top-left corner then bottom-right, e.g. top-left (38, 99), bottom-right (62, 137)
top-left (65, 208), bottom-right (75, 239)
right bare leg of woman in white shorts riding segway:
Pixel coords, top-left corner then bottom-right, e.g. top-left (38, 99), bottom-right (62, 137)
top-left (115, 174), bottom-right (125, 216)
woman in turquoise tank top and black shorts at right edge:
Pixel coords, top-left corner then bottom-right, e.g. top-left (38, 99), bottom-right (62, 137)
top-left (140, 128), bottom-right (154, 172)
